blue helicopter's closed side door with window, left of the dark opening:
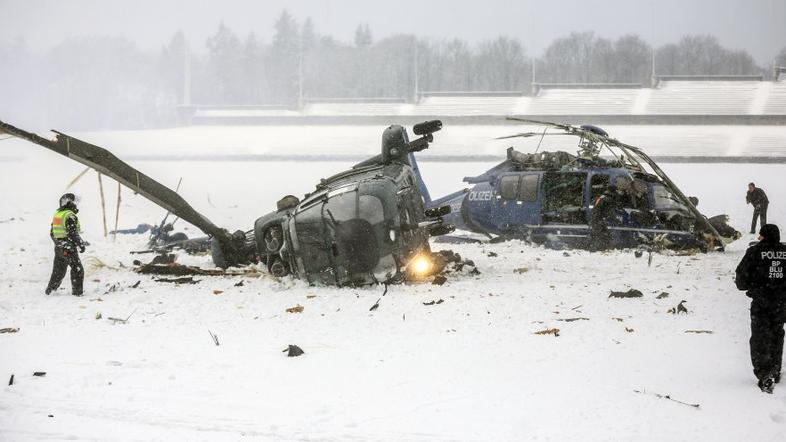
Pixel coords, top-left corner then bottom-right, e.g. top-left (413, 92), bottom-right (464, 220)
top-left (495, 173), bottom-right (540, 232)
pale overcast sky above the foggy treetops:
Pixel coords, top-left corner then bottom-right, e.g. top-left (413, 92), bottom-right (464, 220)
top-left (0, 0), bottom-right (786, 66)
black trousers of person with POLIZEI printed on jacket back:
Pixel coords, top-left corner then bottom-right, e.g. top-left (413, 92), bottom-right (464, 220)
top-left (750, 299), bottom-right (786, 380)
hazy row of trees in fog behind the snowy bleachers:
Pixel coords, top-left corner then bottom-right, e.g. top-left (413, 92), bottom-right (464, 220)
top-left (0, 11), bottom-right (786, 129)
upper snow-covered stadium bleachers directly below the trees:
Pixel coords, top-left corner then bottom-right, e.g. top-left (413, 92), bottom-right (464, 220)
top-left (189, 76), bottom-right (786, 124)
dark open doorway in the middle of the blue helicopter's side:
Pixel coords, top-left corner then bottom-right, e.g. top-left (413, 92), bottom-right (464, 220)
top-left (541, 172), bottom-right (588, 226)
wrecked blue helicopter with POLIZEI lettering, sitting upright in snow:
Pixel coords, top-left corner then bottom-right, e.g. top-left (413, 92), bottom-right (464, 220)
top-left (410, 117), bottom-right (741, 252)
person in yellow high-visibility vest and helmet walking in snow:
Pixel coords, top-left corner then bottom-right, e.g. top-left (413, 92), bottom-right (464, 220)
top-left (46, 193), bottom-right (88, 296)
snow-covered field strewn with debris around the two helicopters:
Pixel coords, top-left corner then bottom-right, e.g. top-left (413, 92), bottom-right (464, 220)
top-left (0, 127), bottom-right (786, 441)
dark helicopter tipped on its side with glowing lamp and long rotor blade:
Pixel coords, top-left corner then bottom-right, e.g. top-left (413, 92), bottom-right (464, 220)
top-left (0, 120), bottom-right (453, 286)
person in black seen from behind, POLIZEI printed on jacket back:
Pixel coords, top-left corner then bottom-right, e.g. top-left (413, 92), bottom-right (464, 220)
top-left (735, 224), bottom-right (786, 393)
